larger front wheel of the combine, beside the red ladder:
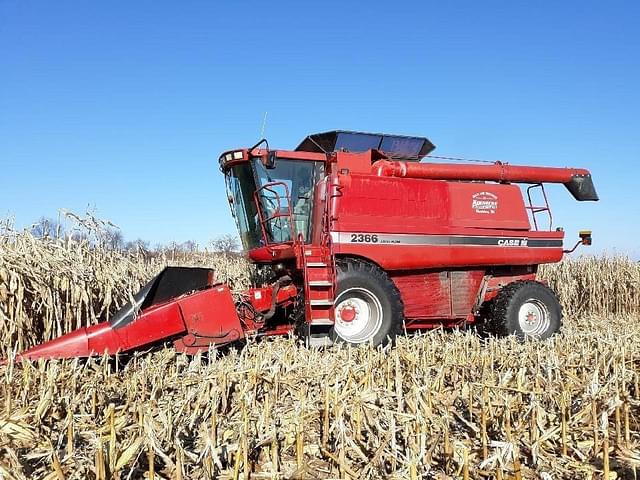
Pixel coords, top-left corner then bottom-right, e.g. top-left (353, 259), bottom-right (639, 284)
top-left (329, 259), bottom-right (404, 345)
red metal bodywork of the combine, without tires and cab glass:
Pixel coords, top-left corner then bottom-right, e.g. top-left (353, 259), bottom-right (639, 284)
top-left (12, 132), bottom-right (597, 359)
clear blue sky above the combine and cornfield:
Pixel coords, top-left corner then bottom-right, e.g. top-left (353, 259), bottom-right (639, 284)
top-left (0, 0), bottom-right (640, 256)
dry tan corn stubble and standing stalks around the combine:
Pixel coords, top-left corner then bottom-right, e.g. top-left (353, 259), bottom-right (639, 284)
top-left (0, 218), bottom-right (640, 479)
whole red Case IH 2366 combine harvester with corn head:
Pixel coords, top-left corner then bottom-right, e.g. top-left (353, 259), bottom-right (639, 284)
top-left (19, 131), bottom-right (598, 359)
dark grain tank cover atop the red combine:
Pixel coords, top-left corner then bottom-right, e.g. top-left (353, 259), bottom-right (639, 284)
top-left (296, 130), bottom-right (436, 161)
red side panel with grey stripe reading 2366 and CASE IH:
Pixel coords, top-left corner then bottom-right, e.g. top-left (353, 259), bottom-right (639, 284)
top-left (331, 174), bottom-right (564, 270)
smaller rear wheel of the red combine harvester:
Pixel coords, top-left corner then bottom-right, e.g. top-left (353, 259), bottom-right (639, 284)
top-left (490, 281), bottom-right (562, 340)
